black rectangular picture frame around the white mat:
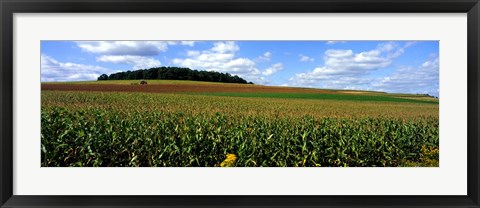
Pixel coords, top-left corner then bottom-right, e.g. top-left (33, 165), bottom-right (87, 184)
top-left (0, 0), bottom-right (480, 208)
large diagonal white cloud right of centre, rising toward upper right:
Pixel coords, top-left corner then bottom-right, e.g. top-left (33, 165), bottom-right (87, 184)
top-left (290, 42), bottom-right (414, 89)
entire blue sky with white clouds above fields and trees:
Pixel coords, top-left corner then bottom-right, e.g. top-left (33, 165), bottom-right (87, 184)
top-left (41, 41), bottom-right (439, 96)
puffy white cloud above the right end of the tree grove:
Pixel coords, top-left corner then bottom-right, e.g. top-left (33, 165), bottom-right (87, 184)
top-left (172, 41), bottom-right (265, 83)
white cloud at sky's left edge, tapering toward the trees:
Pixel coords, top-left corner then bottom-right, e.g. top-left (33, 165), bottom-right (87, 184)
top-left (41, 54), bottom-right (115, 82)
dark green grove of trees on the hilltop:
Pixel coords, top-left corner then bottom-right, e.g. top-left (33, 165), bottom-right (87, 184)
top-left (98, 67), bottom-right (253, 84)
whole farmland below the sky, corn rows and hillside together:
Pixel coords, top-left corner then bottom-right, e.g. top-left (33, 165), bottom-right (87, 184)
top-left (41, 80), bottom-right (439, 167)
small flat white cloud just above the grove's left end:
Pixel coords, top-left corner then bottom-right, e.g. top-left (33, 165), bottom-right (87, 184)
top-left (97, 55), bottom-right (161, 69)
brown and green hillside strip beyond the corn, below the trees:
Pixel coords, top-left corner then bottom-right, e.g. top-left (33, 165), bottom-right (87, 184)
top-left (42, 80), bottom-right (438, 104)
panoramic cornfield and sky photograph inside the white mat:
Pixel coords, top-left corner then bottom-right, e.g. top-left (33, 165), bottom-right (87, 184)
top-left (40, 40), bottom-right (440, 168)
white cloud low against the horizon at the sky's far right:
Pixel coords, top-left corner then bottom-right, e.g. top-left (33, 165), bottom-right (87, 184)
top-left (372, 56), bottom-right (439, 96)
